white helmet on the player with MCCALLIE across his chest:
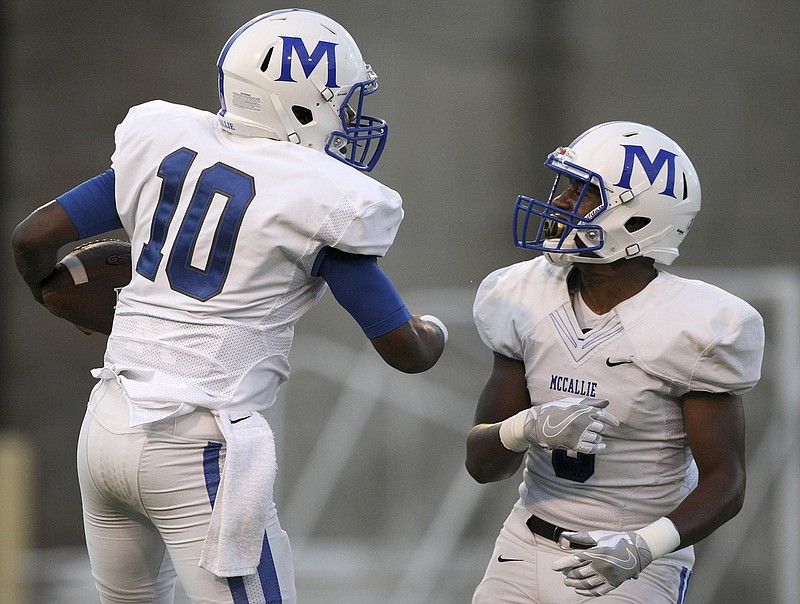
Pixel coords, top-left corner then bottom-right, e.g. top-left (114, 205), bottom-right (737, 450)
top-left (514, 122), bottom-right (700, 266)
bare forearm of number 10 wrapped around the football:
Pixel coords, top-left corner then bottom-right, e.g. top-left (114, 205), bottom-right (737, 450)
top-left (11, 201), bottom-right (78, 304)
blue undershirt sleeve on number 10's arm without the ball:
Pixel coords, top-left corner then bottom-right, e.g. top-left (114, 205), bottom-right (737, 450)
top-left (312, 247), bottom-right (411, 340)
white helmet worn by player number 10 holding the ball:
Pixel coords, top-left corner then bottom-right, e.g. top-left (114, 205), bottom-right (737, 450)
top-left (217, 9), bottom-right (388, 171)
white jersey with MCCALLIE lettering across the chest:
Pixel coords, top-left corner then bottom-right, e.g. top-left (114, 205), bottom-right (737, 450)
top-left (474, 257), bottom-right (764, 531)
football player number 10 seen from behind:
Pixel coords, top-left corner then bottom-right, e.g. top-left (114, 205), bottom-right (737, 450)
top-left (13, 9), bottom-right (447, 604)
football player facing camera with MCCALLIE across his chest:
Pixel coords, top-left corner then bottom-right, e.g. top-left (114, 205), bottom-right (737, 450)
top-left (466, 122), bottom-right (764, 604)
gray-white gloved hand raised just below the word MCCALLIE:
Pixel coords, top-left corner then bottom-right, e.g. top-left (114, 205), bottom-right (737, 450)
top-left (523, 397), bottom-right (619, 454)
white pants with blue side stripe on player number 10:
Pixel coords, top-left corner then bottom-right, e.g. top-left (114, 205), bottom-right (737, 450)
top-left (78, 380), bottom-right (297, 604)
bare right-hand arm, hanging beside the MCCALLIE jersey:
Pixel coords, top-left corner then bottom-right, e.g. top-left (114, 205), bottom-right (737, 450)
top-left (667, 392), bottom-right (745, 547)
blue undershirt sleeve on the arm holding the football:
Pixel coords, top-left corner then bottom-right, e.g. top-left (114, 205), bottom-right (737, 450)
top-left (56, 169), bottom-right (122, 239)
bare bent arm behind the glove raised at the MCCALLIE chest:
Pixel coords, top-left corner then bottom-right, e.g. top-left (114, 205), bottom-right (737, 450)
top-left (466, 355), bottom-right (531, 483)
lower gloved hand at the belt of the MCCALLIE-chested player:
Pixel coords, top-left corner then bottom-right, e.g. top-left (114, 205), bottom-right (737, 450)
top-left (553, 531), bottom-right (653, 596)
